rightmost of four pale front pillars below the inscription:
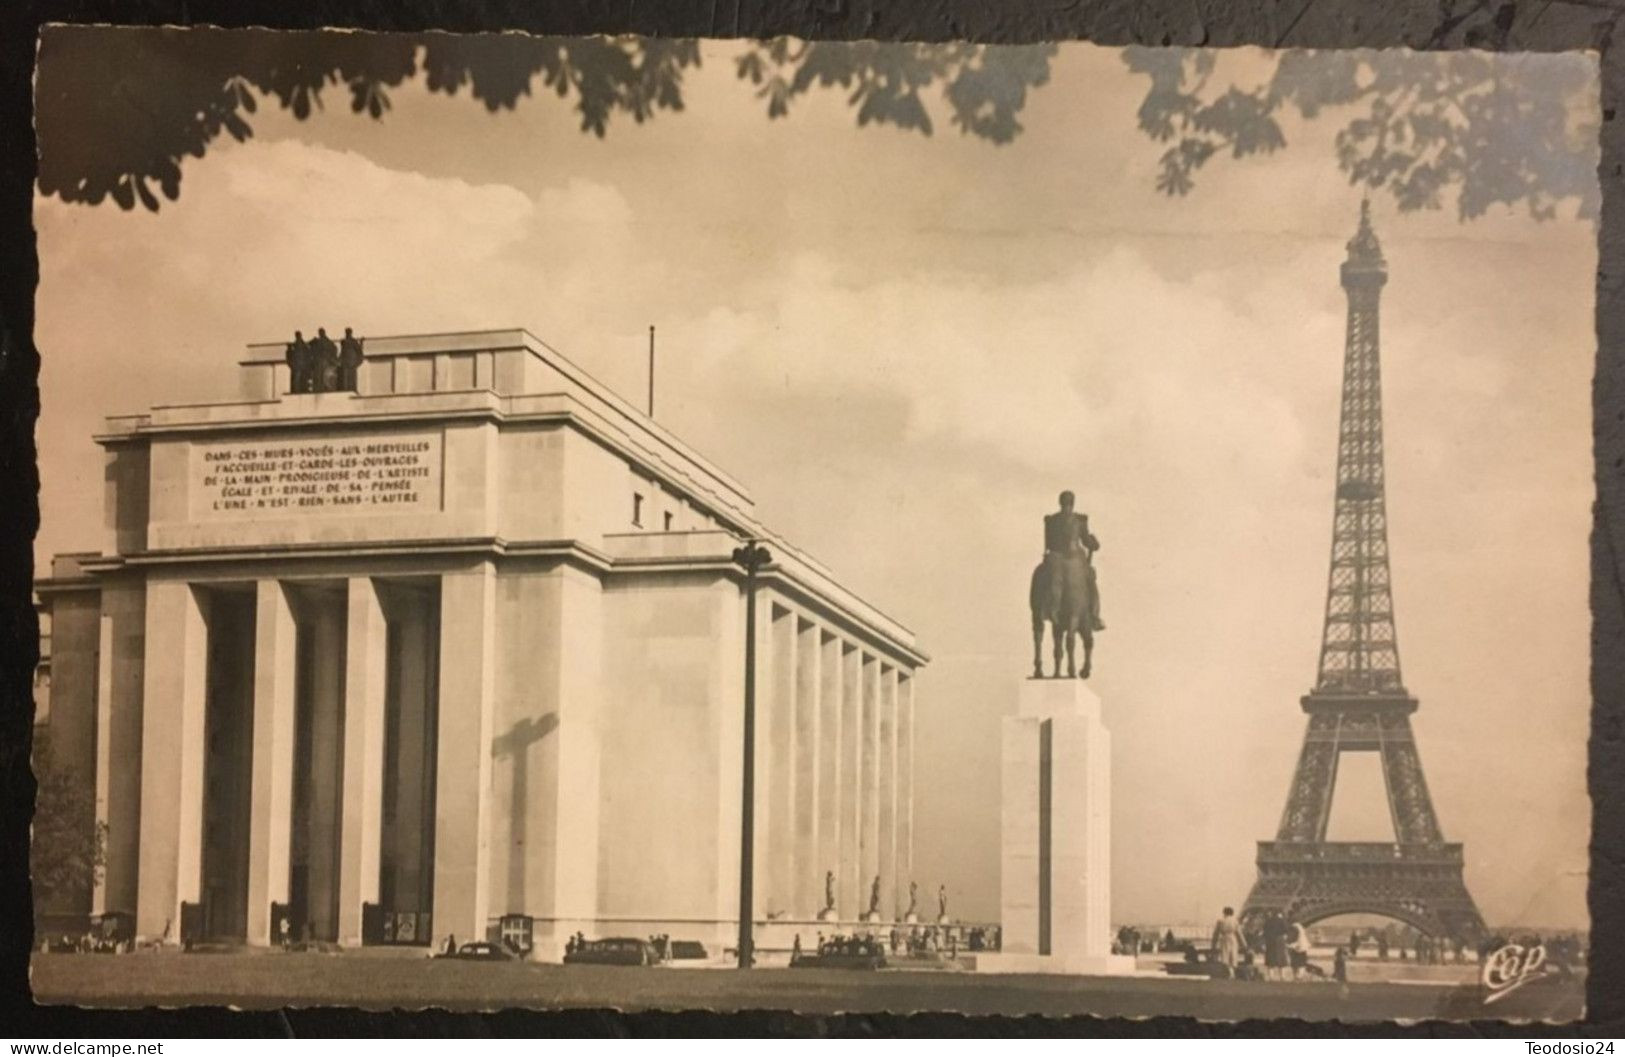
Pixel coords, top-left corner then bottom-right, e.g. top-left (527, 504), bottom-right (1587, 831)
top-left (434, 561), bottom-right (496, 943)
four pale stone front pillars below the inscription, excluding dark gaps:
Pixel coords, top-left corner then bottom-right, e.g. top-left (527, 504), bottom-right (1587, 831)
top-left (131, 563), bottom-right (496, 945)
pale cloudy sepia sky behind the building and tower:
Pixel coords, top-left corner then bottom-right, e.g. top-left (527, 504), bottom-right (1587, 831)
top-left (36, 32), bottom-right (1596, 924)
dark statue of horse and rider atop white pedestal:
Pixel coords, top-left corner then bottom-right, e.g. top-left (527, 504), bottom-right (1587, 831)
top-left (1029, 491), bottom-right (1107, 680)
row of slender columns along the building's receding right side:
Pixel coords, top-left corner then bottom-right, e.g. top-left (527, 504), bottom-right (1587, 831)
top-left (756, 603), bottom-right (913, 920)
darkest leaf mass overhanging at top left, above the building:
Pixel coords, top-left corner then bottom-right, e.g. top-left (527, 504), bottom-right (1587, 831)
top-left (34, 28), bottom-right (699, 210)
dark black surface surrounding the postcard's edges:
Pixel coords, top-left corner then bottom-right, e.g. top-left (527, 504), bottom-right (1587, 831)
top-left (0, 0), bottom-right (1625, 1037)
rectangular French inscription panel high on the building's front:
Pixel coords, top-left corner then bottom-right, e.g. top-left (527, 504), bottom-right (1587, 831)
top-left (190, 433), bottom-right (442, 519)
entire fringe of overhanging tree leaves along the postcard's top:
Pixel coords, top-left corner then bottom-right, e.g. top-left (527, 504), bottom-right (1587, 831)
top-left (36, 26), bottom-right (1599, 220)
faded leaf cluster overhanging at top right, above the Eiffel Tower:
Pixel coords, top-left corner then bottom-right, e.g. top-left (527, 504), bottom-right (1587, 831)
top-left (1123, 47), bottom-right (1601, 220)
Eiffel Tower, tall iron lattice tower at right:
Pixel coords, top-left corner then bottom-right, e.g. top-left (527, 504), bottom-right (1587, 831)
top-left (1242, 203), bottom-right (1484, 940)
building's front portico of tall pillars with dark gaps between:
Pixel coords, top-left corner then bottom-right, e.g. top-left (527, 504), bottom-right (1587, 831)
top-left (131, 563), bottom-right (496, 945)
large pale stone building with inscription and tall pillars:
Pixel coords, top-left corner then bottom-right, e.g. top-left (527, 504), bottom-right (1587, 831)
top-left (37, 330), bottom-right (926, 950)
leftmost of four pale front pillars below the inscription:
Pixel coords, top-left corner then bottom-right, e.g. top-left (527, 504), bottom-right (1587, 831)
top-left (135, 579), bottom-right (208, 942)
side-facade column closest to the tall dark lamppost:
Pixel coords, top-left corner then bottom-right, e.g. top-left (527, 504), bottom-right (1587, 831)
top-left (770, 605), bottom-right (798, 914)
